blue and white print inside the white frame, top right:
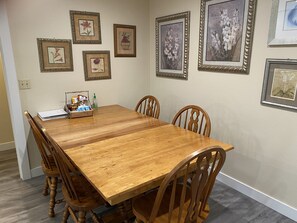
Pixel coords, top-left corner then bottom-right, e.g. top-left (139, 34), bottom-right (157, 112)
top-left (283, 0), bottom-right (297, 30)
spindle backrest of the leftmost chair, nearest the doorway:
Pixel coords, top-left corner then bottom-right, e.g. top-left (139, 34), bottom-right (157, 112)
top-left (25, 111), bottom-right (53, 170)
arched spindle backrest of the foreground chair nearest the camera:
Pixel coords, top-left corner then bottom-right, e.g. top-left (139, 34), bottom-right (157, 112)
top-left (149, 146), bottom-right (226, 223)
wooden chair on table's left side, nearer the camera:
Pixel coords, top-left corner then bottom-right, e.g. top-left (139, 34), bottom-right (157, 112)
top-left (43, 129), bottom-right (105, 223)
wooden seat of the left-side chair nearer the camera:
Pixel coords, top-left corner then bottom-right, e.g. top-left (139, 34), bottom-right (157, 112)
top-left (62, 176), bottom-right (106, 211)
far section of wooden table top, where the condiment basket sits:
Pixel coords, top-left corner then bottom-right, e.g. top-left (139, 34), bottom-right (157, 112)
top-left (34, 105), bottom-right (168, 150)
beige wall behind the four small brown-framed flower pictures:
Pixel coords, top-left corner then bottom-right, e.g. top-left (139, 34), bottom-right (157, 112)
top-left (7, 0), bottom-right (149, 168)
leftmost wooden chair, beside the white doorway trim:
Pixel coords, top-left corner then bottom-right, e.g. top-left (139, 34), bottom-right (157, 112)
top-left (25, 111), bottom-right (61, 217)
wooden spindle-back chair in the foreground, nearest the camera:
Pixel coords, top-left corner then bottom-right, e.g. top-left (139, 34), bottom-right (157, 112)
top-left (132, 146), bottom-right (226, 223)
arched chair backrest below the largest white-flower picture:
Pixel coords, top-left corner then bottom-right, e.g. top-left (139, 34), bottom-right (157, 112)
top-left (172, 105), bottom-right (211, 137)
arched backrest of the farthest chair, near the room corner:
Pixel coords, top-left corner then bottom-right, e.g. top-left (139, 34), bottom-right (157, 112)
top-left (135, 95), bottom-right (160, 118)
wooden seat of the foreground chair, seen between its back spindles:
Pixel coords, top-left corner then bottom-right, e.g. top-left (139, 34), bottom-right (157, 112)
top-left (132, 185), bottom-right (208, 223)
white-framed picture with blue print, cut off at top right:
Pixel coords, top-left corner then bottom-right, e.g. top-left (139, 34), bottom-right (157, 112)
top-left (268, 0), bottom-right (297, 46)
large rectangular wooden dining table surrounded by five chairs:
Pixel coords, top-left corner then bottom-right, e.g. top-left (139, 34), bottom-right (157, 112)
top-left (34, 105), bottom-right (233, 216)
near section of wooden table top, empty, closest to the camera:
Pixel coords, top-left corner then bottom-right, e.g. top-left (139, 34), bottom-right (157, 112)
top-left (65, 124), bottom-right (233, 205)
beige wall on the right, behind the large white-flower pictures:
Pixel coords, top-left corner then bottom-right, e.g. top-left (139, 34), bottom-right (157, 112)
top-left (150, 0), bottom-right (297, 208)
